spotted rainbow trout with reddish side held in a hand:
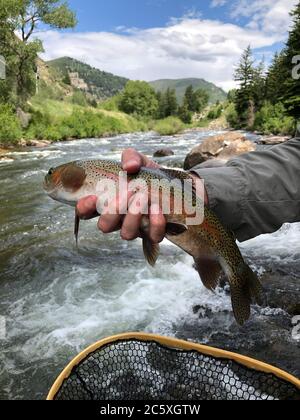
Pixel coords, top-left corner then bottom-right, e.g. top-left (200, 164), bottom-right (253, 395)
top-left (44, 159), bottom-right (262, 325)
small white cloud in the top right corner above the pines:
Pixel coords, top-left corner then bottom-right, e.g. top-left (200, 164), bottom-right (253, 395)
top-left (231, 0), bottom-right (298, 35)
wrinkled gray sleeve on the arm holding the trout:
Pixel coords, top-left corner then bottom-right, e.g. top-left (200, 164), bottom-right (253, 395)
top-left (192, 138), bottom-right (300, 242)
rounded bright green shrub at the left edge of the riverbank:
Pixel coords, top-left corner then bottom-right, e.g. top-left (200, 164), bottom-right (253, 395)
top-left (0, 105), bottom-right (22, 144)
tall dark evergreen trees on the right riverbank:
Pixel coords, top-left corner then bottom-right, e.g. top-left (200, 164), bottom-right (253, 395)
top-left (228, 2), bottom-right (300, 134)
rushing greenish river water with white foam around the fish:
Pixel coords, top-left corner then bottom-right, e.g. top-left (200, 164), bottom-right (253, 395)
top-left (0, 132), bottom-right (300, 399)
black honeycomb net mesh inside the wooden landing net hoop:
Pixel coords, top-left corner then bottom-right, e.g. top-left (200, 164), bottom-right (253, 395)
top-left (54, 340), bottom-right (299, 401)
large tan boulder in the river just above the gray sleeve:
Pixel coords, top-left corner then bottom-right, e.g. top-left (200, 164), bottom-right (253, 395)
top-left (184, 132), bottom-right (256, 170)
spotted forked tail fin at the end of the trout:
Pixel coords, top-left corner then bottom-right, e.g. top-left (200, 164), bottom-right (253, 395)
top-left (228, 263), bottom-right (262, 325)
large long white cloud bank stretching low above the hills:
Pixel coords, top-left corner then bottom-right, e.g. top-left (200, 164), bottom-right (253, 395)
top-left (40, 18), bottom-right (280, 90)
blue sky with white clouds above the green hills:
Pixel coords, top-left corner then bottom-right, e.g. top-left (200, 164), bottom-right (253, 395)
top-left (40, 0), bottom-right (297, 90)
